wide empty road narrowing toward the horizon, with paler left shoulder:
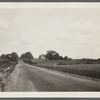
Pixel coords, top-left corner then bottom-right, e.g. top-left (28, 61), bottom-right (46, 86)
top-left (5, 61), bottom-right (100, 92)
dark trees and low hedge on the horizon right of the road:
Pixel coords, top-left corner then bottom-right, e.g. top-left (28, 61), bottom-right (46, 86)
top-left (39, 50), bottom-right (100, 64)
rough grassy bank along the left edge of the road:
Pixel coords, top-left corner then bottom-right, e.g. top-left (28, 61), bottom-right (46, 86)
top-left (0, 62), bottom-right (17, 91)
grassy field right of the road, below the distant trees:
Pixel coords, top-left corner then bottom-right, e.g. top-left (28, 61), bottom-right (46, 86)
top-left (36, 61), bottom-right (100, 79)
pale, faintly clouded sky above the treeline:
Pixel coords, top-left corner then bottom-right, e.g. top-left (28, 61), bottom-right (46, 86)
top-left (0, 8), bottom-right (100, 58)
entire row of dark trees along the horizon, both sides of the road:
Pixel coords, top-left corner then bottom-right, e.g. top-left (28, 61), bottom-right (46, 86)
top-left (0, 50), bottom-right (100, 64)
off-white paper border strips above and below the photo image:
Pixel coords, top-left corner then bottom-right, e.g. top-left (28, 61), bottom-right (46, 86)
top-left (0, 2), bottom-right (100, 98)
